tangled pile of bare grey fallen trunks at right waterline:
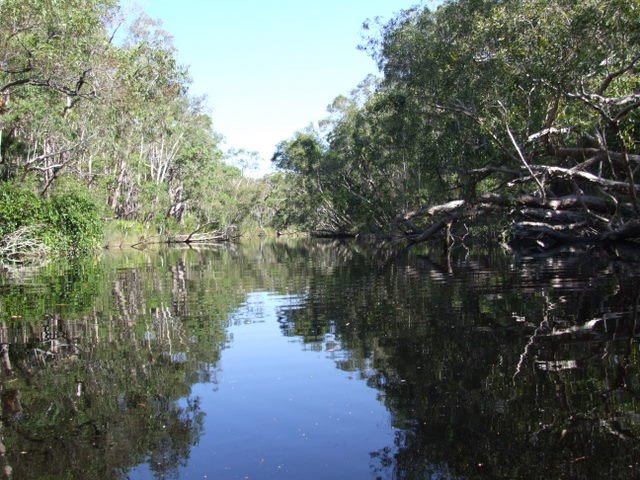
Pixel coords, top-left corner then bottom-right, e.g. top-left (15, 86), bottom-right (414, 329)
top-left (395, 157), bottom-right (640, 249)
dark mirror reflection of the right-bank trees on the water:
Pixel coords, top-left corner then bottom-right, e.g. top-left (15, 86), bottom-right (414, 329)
top-left (280, 246), bottom-right (640, 478)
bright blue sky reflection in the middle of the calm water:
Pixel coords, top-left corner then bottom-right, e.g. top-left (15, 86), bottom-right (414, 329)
top-left (130, 292), bottom-right (394, 479)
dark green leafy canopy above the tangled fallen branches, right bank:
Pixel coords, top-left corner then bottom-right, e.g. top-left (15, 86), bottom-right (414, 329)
top-left (274, 0), bottom-right (640, 236)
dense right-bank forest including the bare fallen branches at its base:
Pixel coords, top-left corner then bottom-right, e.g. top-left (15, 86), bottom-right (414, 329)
top-left (274, 0), bottom-right (640, 248)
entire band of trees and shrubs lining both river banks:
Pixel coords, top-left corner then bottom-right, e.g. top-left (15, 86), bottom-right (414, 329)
top-left (0, 0), bottom-right (640, 264)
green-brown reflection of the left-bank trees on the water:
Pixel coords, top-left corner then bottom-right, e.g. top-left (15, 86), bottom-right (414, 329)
top-left (0, 252), bottom-right (250, 478)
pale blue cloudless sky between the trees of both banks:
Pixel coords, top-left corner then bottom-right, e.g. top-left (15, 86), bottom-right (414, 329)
top-left (124, 0), bottom-right (435, 176)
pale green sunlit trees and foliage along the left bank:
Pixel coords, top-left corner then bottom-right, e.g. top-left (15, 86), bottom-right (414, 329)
top-left (0, 0), bottom-right (253, 249)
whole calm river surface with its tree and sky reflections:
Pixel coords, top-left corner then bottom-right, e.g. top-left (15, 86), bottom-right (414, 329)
top-left (0, 240), bottom-right (640, 480)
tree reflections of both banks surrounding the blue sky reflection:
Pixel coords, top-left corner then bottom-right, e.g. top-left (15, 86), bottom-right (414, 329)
top-left (0, 241), bottom-right (640, 478)
